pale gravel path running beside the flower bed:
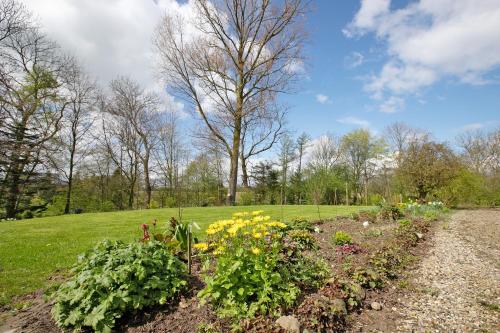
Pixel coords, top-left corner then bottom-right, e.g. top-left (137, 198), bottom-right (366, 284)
top-left (397, 210), bottom-right (500, 332)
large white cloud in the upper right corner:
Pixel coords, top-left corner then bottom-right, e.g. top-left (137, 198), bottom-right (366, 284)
top-left (344, 0), bottom-right (500, 103)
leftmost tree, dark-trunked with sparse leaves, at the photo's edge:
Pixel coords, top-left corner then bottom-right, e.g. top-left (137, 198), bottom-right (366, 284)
top-left (0, 11), bottom-right (68, 218)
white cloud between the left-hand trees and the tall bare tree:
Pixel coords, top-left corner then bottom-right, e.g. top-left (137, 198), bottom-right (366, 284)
top-left (22, 0), bottom-right (194, 88)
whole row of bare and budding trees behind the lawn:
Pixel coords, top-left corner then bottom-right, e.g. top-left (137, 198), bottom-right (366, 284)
top-left (0, 0), bottom-right (500, 218)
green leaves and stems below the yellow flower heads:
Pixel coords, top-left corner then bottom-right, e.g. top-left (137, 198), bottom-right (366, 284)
top-left (199, 237), bottom-right (300, 319)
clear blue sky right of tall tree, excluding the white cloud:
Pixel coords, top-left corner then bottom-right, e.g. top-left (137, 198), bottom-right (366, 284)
top-left (283, 0), bottom-right (500, 141)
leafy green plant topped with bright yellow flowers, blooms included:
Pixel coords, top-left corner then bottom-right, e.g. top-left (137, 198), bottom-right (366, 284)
top-left (199, 212), bottom-right (328, 320)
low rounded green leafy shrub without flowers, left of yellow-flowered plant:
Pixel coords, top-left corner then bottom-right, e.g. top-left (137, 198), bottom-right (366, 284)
top-left (52, 241), bottom-right (187, 331)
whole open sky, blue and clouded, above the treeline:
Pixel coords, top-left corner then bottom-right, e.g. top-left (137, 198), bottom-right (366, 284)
top-left (22, 0), bottom-right (500, 142)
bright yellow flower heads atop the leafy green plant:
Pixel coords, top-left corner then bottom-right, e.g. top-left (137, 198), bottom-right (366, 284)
top-left (203, 210), bottom-right (286, 254)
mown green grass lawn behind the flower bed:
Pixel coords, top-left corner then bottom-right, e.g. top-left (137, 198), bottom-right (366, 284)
top-left (0, 206), bottom-right (366, 304)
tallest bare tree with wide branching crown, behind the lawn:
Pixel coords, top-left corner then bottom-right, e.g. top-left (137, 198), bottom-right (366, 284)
top-left (155, 0), bottom-right (306, 204)
